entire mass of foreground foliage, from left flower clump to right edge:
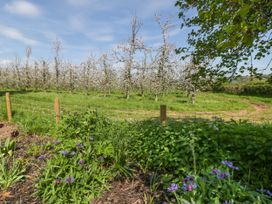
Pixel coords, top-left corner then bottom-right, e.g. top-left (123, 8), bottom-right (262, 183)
top-left (37, 111), bottom-right (272, 203)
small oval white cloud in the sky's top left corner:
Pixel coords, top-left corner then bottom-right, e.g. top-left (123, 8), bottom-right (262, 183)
top-left (5, 0), bottom-right (41, 17)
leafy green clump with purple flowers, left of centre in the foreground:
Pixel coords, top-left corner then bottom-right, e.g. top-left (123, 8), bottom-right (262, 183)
top-left (37, 112), bottom-right (134, 203)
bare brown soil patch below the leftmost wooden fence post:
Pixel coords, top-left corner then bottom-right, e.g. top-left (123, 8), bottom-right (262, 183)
top-left (0, 124), bottom-right (52, 204)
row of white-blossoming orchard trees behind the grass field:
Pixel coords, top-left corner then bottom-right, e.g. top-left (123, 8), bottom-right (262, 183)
top-left (0, 15), bottom-right (210, 103)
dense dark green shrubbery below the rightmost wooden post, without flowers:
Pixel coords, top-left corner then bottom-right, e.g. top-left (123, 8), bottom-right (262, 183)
top-left (129, 119), bottom-right (272, 188)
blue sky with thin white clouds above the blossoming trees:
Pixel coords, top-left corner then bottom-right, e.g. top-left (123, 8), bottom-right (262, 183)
top-left (0, 0), bottom-right (186, 63)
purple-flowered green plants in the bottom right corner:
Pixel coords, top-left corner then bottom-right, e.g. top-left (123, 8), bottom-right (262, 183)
top-left (166, 161), bottom-right (272, 204)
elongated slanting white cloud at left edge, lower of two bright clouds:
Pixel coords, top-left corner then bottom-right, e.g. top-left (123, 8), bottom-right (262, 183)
top-left (0, 25), bottom-right (37, 45)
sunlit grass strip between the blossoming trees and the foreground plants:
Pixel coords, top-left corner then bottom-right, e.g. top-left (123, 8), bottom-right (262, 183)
top-left (0, 91), bottom-right (272, 133)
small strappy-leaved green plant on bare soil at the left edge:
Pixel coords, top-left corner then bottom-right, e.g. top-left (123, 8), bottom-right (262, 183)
top-left (0, 158), bottom-right (25, 190)
